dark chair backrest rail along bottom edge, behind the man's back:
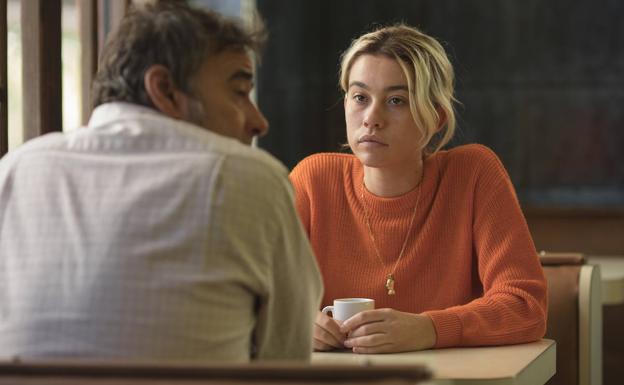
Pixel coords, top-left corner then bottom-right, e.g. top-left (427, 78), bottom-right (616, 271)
top-left (0, 359), bottom-right (431, 385)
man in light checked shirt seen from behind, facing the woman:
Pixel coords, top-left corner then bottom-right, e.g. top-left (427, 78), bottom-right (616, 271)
top-left (0, 2), bottom-right (322, 361)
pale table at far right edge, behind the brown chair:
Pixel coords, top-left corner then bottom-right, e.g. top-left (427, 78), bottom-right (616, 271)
top-left (587, 256), bottom-right (624, 305)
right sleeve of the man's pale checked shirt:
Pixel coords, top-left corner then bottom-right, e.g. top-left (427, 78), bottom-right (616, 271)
top-left (219, 154), bottom-right (322, 360)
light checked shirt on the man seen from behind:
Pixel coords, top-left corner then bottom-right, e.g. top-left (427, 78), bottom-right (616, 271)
top-left (0, 103), bottom-right (321, 360)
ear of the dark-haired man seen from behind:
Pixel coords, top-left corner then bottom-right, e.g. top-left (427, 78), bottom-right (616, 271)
top-left (143, 64), bottom-right (188, 119)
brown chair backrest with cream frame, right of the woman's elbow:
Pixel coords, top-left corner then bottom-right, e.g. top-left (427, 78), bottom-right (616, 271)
top-left (540, 252), bottom-right (602, 385)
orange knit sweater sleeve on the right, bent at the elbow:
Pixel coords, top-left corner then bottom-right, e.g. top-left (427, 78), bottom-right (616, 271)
top-left (425, 148), bottom-right (547, 347)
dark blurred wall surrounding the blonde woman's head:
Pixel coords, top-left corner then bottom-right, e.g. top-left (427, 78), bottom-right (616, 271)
top-left (257, 0), bottom-right (624, 210)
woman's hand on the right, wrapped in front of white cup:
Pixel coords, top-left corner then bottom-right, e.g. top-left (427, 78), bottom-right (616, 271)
top-left (340, 309), bottom-right (437, 353)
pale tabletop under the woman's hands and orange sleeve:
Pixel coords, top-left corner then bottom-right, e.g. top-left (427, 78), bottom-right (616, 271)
top-left (312, 339), bottom-right (556, 385)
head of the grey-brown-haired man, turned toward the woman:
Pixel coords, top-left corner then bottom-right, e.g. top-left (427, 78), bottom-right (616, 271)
top-left (93, 1), bottom-right (268, 143)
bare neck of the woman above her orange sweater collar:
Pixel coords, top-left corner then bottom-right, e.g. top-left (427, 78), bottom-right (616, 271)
top-left (364, 158), bottom-right (423, 197)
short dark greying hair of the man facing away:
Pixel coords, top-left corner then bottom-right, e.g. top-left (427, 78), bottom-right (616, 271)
top-left (92, 0), bottom-right (267, 107)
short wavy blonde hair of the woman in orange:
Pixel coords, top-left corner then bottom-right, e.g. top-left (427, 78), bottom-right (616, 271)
top-left (340, 24), bottom-right (457, 154)
